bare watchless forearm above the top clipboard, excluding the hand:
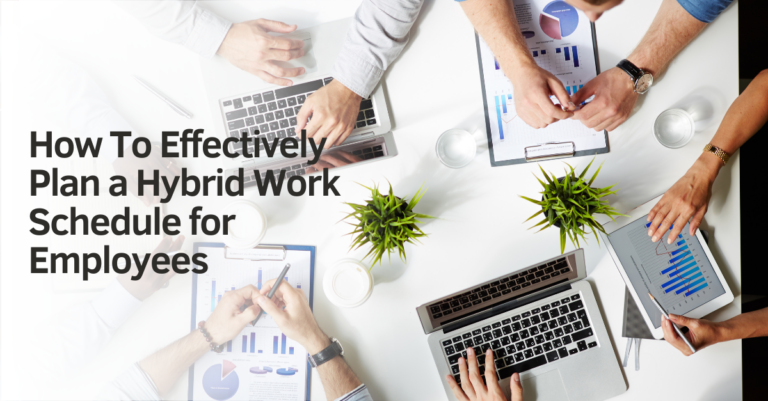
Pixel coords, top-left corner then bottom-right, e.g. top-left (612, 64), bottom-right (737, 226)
top-left (461, 0), bottom-right (534, 69)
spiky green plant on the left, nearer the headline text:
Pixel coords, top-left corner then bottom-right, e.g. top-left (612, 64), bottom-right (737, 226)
top-left (342, 185), bottom-right (434, 268)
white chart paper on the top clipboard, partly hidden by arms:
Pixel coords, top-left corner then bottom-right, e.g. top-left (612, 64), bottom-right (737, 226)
top-left (476, 0), bottom-right (608, 166)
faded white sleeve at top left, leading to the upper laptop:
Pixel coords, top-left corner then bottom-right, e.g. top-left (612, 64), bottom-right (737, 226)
top-left (114, 0), bottom-right (232, 57)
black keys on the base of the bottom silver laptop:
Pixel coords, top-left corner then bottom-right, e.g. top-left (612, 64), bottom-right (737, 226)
top-left (441, 294), bottom-right (597, 382)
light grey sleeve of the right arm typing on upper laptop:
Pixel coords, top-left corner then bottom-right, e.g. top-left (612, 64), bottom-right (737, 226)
top-left (332, 0), bottom-right (423, 98)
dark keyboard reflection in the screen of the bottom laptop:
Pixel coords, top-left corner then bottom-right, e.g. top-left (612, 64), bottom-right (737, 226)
top-left (429, 258), bottom-right (571, 319)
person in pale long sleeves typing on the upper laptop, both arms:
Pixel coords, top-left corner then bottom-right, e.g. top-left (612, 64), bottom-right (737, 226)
top-left (116, 0), bottom-right (424, 147)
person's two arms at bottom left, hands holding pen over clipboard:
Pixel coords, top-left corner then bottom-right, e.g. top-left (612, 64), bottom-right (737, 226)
top-left (100, 279), bottom-right (372, 401)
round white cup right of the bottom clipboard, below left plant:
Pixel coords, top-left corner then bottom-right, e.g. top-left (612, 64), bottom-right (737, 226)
top-left (323, 259), bottom-right (373, 308)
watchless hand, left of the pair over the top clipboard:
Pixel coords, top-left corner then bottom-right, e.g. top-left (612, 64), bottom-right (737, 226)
top-left (504, 62), bottom-right (576, 128)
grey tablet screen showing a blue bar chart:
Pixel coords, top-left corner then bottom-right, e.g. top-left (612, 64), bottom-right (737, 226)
top-left (608, 215), bottom-right (725, 328)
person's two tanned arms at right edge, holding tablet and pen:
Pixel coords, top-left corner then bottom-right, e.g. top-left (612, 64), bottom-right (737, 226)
top-left (648, 70), bottom-right (768, 355)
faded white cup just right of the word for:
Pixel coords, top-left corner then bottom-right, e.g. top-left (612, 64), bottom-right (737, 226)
top-left (221, 200), bottom-right (267, 249)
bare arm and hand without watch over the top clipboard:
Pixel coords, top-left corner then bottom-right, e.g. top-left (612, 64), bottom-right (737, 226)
top-left (461, 0), bottom-right (575, 128)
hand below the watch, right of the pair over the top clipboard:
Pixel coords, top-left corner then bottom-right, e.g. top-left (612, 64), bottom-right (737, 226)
top-left (571, 67), bottom-right (638, 132)
